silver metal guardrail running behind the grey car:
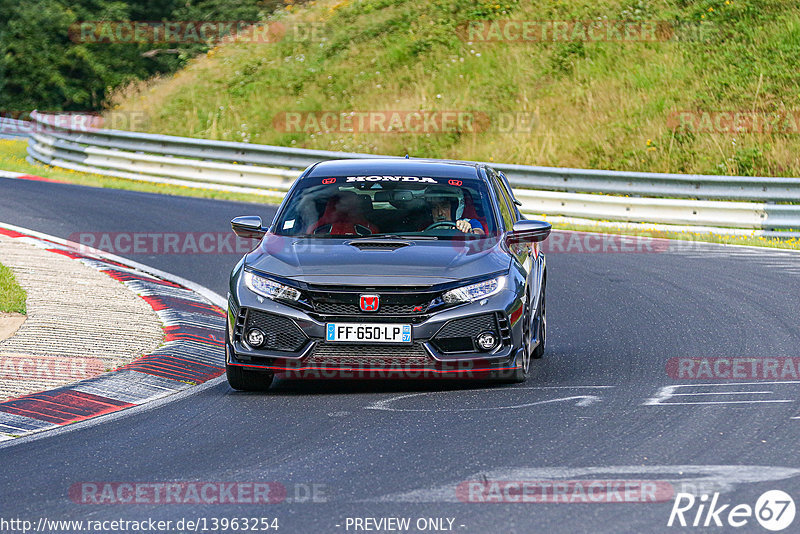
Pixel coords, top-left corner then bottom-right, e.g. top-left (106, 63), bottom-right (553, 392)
top-left (21, 112), bottom-right (800, 236)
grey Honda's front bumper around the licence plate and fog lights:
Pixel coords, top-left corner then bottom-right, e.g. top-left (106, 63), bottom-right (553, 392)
top-left (226, 289), bottom-right (523, 378)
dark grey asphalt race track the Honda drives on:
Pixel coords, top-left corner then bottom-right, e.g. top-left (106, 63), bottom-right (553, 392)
top-left (0, 179), bottom-right (800, 533)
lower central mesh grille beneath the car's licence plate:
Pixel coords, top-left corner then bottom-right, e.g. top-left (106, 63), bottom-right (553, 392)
top-left (303, 342), bottom-right (434, 368)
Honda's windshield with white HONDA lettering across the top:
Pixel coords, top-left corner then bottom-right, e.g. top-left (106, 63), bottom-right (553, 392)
top-left (275, 176), bottom-right (497, 239)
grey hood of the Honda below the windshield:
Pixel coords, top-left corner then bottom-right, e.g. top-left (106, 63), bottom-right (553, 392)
top-left (245, 234), bottom-right (511, 286)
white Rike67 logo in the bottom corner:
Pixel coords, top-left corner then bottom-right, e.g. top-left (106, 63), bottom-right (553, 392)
top-left (667, 490), bottom-right (796, 532)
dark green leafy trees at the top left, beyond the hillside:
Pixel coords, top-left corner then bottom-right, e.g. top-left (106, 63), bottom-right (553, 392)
top-left (0, 0), bottom-right (276, 111)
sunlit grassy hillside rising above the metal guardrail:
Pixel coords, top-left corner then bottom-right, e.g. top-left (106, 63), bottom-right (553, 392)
top-left (108, 0), bottom-right (800, 176)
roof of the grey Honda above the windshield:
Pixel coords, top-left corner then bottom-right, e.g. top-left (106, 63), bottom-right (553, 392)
top-left (306, 158), bottom-right (481, 179)
